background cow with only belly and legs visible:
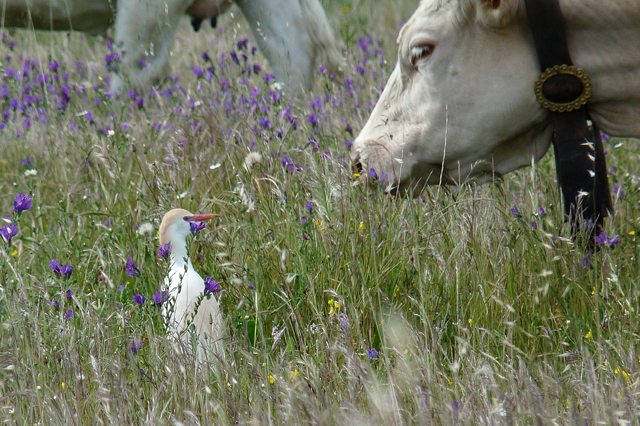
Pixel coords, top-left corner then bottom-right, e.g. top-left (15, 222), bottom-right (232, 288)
top-left (0, 0), bottom-right (342, 93)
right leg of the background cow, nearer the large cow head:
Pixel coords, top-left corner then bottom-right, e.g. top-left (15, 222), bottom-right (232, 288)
top-left (236, 0), bottom-right (342, 87)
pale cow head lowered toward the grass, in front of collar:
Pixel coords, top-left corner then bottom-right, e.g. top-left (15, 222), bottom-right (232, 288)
top-left (351, 0), bottom-right (551, 192)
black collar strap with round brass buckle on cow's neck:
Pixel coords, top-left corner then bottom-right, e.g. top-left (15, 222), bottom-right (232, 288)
top-left (525, 0), bottom-right (613, 232)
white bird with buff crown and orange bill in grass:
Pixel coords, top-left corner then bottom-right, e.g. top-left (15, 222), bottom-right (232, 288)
top-left (159, 209), bottom-right (224, 360)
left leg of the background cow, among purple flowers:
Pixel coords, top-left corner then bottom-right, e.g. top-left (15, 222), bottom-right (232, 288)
top-left (110, 0), bottom-right (190, 93)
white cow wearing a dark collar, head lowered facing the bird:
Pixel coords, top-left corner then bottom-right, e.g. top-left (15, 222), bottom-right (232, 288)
top-left (351, 0), bottom-right (640, 192)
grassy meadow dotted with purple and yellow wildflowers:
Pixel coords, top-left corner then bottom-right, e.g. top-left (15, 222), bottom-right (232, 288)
top-left (0, 0), bottom-right (640, 425)
